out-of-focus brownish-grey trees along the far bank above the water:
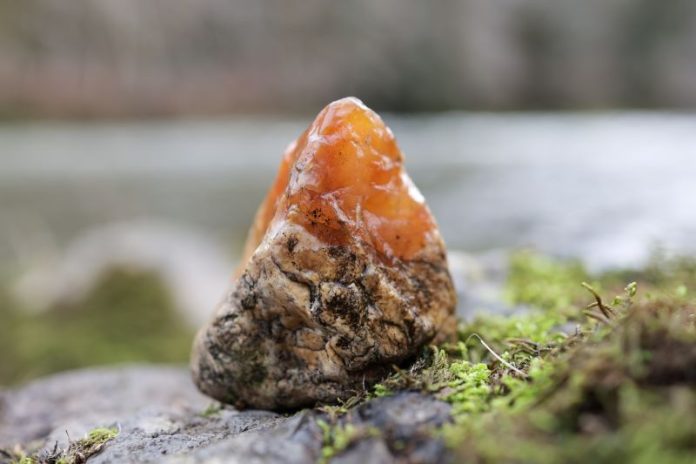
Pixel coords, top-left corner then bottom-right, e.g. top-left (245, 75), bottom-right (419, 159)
top-left (0, 0), bottom-right (696, 116)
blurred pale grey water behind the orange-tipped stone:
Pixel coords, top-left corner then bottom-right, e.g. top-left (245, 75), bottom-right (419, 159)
top-left (0, 113), bottom-right (696, 267)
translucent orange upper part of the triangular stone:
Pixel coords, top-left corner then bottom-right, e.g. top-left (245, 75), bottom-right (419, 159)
top-left (242, 97), bottom-right (438, 266)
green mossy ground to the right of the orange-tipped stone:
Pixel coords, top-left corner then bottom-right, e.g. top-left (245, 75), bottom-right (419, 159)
top-left (324, 252), bottom-right (696, 463)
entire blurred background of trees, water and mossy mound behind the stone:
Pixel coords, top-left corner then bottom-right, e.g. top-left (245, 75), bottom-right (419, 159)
top-left (0, 0), bottom-right (696, 385)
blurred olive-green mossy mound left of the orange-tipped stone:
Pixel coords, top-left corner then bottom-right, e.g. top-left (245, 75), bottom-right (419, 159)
top-left (0, 269), bottom-right (193, 385)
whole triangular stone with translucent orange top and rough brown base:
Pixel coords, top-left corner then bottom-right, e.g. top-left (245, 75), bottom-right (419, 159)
top-left (192, 98), bottom-right (456, 410)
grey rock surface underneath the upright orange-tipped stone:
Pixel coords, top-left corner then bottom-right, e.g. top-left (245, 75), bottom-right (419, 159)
top-left (0, 366), bottom-right (449, 464)
